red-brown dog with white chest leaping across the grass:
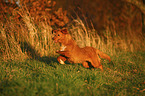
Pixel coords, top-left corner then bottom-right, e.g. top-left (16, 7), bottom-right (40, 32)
top-left (53, 29), bottom-right (111, 71)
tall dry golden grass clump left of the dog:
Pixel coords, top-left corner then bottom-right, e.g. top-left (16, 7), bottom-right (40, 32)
top-left (0, 10), bottom-right (57, 60)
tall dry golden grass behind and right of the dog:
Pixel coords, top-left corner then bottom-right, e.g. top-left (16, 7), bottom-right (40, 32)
top-left (69, 18), bottom-right (145, 55)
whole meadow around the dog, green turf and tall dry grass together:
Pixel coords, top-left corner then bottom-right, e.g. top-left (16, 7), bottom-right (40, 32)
top-left (0, 0), bottom-right (145, 96)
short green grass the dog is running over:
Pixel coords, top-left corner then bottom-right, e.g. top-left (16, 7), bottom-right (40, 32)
top-left (0, 52), bottom-right (145, 96)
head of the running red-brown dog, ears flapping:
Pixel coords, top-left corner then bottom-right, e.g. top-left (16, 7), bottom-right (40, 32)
top-left (52, 29), bottom-right (71, 43)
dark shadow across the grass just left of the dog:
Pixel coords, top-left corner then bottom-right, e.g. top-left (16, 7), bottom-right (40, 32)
top-left (21, 42), bottom-right (58, 67)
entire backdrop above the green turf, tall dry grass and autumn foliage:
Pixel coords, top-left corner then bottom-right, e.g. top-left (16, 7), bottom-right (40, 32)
top-left (0, 0), bottom-right (145, 59)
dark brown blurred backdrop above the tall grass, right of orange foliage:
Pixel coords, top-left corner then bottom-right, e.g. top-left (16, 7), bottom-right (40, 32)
top-left (56, 0), bottom-right (145, 33)
